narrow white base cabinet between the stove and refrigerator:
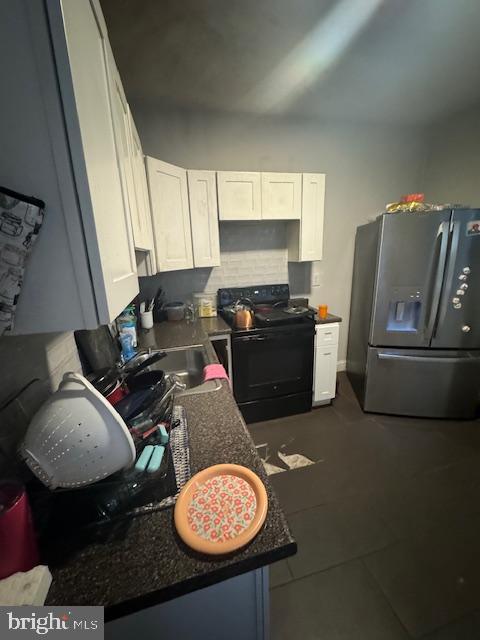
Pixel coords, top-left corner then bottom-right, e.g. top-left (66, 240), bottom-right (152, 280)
top-left (312, 322), bottom-right (340, 406)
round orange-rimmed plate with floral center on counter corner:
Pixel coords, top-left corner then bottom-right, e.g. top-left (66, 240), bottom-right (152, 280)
top-left (174, 464), bottom-right (268, 555)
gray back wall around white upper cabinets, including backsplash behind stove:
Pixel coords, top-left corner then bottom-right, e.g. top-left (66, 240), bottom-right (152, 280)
top-left (132, 104), bottom-right (424, 361)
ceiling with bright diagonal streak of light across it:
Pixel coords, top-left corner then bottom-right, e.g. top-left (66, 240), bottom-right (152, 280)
top-left (101, 0), bottom-right (480, 124)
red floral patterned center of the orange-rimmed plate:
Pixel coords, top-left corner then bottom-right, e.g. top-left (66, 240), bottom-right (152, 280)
top-left (187, 474), bottom-right (257, 542)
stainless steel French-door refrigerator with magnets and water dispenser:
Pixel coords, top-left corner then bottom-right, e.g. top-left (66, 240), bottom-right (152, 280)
top-left (347, 209), bottom-right (480, 418)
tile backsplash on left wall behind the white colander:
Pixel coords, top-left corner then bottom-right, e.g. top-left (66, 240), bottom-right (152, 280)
top-left (0, 332), bottom-right (81, 473)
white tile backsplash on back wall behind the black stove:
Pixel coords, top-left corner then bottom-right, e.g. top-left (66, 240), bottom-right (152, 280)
top-left (140, 221), bottom-right (302, 301)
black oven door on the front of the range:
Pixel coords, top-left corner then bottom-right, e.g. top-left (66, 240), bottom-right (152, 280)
top-left (232, 325), bottom-right (314, 403)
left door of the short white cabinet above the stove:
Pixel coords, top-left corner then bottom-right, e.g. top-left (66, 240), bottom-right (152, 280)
top-left (217, 171), bottom-right (262, 220)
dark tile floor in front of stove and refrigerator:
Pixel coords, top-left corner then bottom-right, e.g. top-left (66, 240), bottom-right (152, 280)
top-left (249, 374), bottom-right (480, 640)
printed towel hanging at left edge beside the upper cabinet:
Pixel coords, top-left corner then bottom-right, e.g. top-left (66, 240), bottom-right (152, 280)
top-left (0, 187), bottom-right (45, 336)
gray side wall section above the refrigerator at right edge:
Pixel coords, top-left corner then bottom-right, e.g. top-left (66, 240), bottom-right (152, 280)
top-left (423, 108), bottom-right (480, 207)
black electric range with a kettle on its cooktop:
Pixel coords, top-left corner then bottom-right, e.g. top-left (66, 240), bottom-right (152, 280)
top-left (218, 284), bottom-right (315, 422)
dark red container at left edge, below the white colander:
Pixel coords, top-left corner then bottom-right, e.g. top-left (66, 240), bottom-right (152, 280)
top-left (0, 480), bottom-right (38, 579)
